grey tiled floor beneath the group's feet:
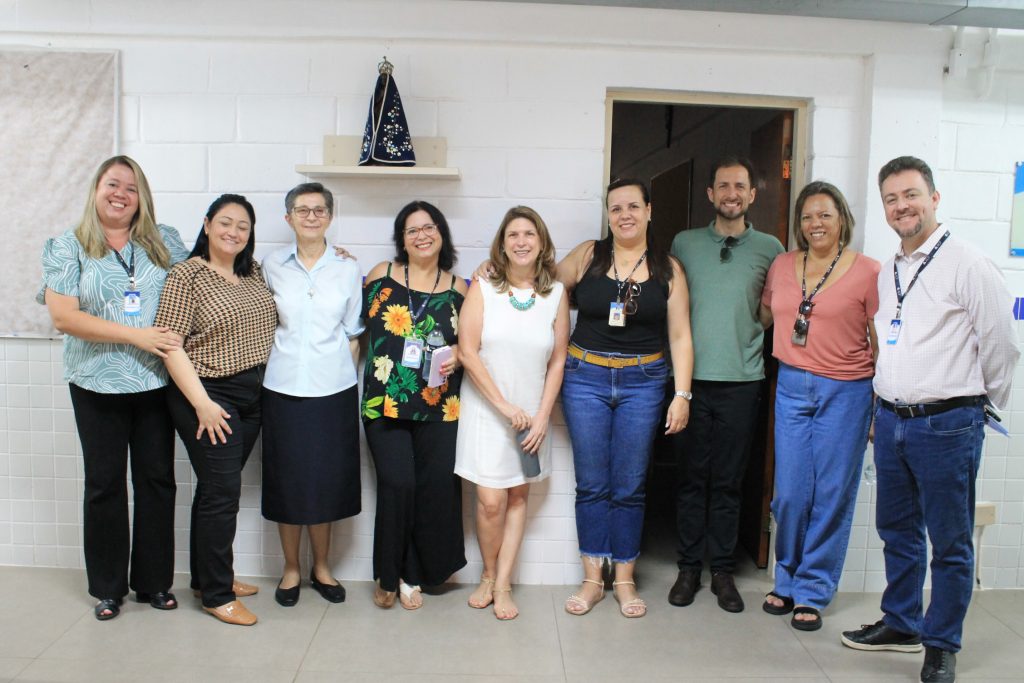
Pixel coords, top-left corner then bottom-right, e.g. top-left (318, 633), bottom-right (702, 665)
top-left (0, 560), bottom-right (1024, 683)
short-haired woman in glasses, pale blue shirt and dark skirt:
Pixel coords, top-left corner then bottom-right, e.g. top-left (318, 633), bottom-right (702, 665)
top-left (262, 182), bottom-right (362, 607)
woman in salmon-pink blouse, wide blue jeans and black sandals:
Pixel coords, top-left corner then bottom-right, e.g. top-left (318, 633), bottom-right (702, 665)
top-left (761, 181), bottom-right (880, 631)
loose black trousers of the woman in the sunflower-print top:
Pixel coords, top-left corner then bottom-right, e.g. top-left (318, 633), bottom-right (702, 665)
top-left (364, 418), bottom-right (466, 591)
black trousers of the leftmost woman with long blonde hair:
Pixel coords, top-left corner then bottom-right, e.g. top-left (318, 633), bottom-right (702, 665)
top-left (70, 384), bottom-right (176, 600)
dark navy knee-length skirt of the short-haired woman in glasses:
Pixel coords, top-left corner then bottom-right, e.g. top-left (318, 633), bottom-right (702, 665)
top-left (263, 386), bottom-right (360, 524)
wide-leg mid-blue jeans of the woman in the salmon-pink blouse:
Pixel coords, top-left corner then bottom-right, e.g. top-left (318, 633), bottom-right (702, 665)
top-left (771, 362), bottom-right (871, 609)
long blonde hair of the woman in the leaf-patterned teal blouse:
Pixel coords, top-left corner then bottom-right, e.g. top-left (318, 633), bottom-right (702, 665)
top-left (75, 155), bottom-right (171, 270)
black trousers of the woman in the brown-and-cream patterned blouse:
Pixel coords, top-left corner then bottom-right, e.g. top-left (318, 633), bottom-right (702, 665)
top-left (167, 367), bottom-right (263, 607)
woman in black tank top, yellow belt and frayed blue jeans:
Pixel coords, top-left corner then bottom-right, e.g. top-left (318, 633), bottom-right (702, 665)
top-left (558, 180), bottom-right (693, 617)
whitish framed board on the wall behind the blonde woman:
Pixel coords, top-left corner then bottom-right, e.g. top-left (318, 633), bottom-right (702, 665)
top-left (0, 48), bottom-right (119, 337)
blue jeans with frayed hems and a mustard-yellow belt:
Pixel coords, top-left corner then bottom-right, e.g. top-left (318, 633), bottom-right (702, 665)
top-left (562, 355), bottom-right (669, 562)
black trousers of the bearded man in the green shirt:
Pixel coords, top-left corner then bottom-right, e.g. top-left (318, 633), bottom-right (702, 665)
top-left (676, 381), bottom-right (763, 573)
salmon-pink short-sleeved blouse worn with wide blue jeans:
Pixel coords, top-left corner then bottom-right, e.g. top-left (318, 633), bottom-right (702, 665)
top-left (761, 251), bottom-right (881, 380)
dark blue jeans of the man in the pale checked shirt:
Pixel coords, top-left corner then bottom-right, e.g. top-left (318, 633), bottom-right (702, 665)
top-left (874, 405), bottom-right (985, 652)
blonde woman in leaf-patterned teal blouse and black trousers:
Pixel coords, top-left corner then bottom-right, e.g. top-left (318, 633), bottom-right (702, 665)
top-left (39, 157), bottom-right (188, 621)
